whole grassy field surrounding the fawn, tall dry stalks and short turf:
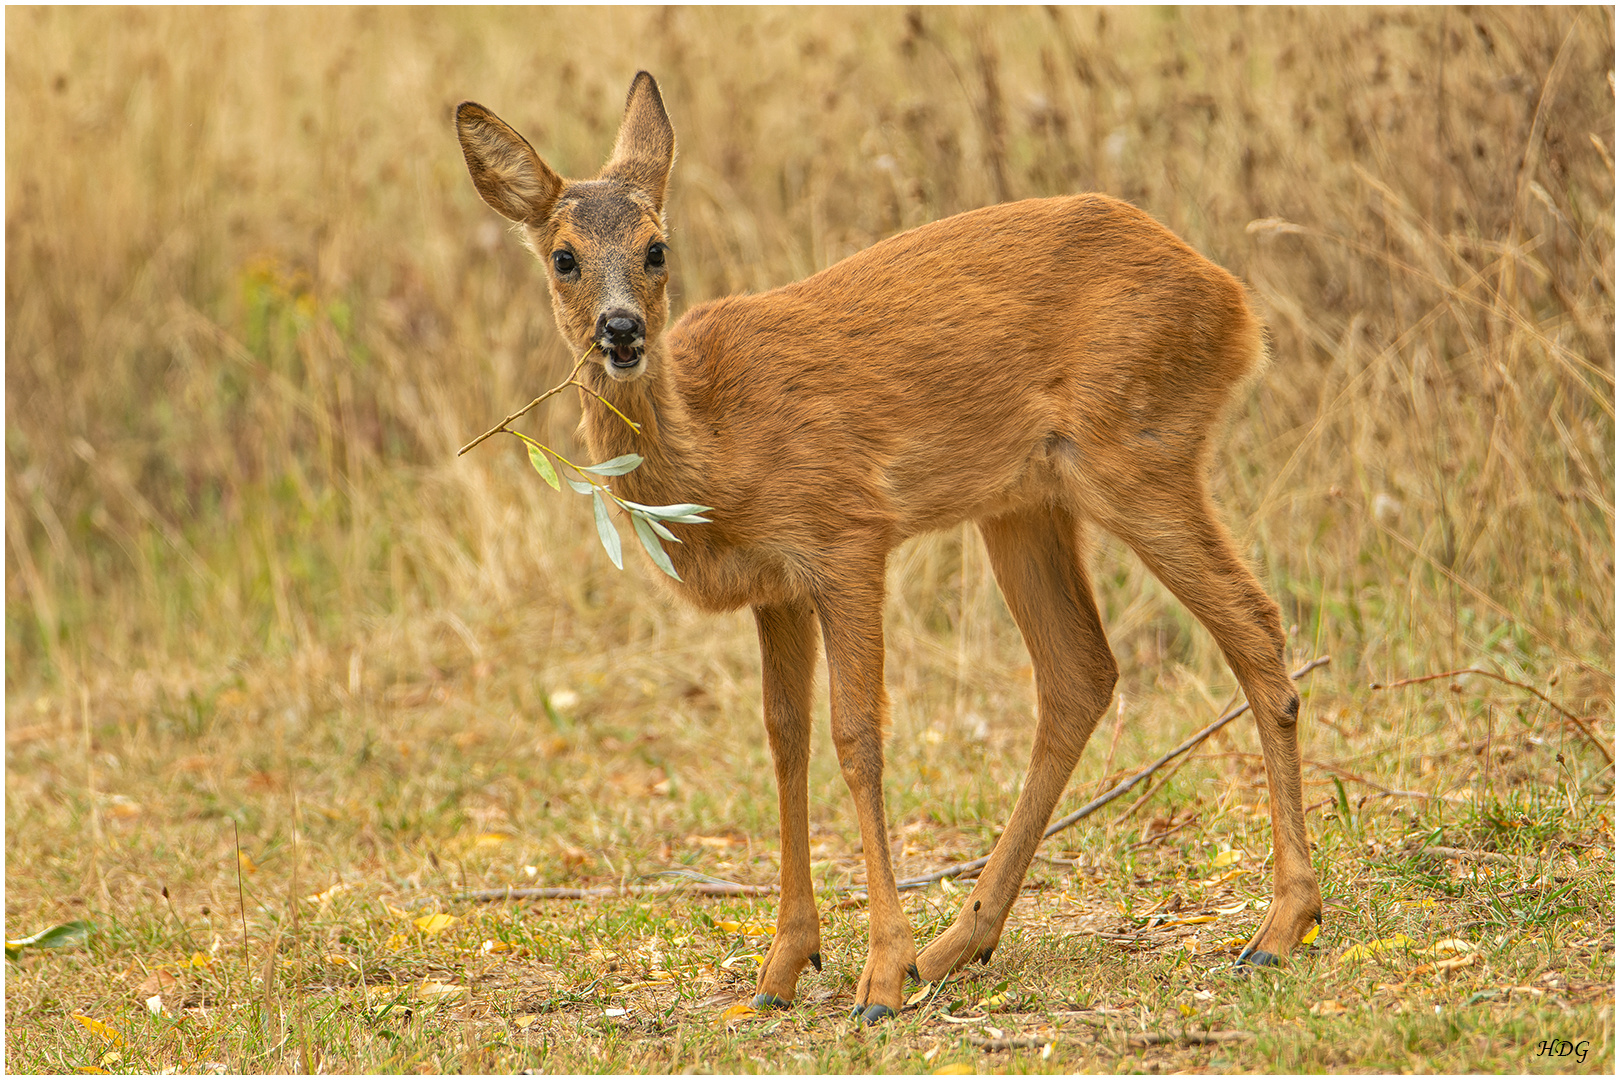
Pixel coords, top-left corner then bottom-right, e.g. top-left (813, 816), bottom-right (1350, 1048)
top-left (5, 8), bottom-right (1615, 1072)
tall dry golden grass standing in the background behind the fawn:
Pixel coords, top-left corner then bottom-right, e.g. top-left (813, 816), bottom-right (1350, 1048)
top-left (5, 8), bottom-right (1615, 712)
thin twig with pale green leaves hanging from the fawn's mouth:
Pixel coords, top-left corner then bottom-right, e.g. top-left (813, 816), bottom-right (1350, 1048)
top-left (455, 342), bottom-right (713, 581)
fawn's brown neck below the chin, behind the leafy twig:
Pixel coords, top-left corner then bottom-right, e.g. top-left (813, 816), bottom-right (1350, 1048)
top-left (580, 343), bottom-right (705, 504)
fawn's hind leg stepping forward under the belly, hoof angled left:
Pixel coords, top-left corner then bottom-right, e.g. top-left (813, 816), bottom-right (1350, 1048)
top-left (917, 507), bottom-right (1119, 981)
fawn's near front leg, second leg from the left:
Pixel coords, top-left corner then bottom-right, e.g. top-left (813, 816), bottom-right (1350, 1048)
top-left (816, 562), bottom-right (917, 1023)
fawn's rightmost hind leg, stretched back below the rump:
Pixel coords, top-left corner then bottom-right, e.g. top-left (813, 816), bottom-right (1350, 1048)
top-left (1106, 481), bottom-right (1322, 965)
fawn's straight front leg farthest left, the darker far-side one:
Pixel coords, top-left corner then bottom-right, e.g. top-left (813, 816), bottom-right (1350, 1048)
top-left (753, 604), bottom-right (821, 1009)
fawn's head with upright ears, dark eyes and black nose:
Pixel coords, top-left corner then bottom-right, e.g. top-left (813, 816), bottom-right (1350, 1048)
top-left (455, 71), bottom-right (676, 379)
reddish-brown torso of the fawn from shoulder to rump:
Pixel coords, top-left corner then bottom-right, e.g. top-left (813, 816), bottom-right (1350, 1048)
top-left (667, 194), bottom-right (1260, 550)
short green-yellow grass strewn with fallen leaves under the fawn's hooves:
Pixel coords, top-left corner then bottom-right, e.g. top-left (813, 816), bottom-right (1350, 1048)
top-left (6, 641), bottom-right (1614, 1072)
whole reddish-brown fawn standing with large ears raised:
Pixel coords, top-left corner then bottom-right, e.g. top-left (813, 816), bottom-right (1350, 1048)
top-left (455, 71), bottom-right (1322, 1022)
